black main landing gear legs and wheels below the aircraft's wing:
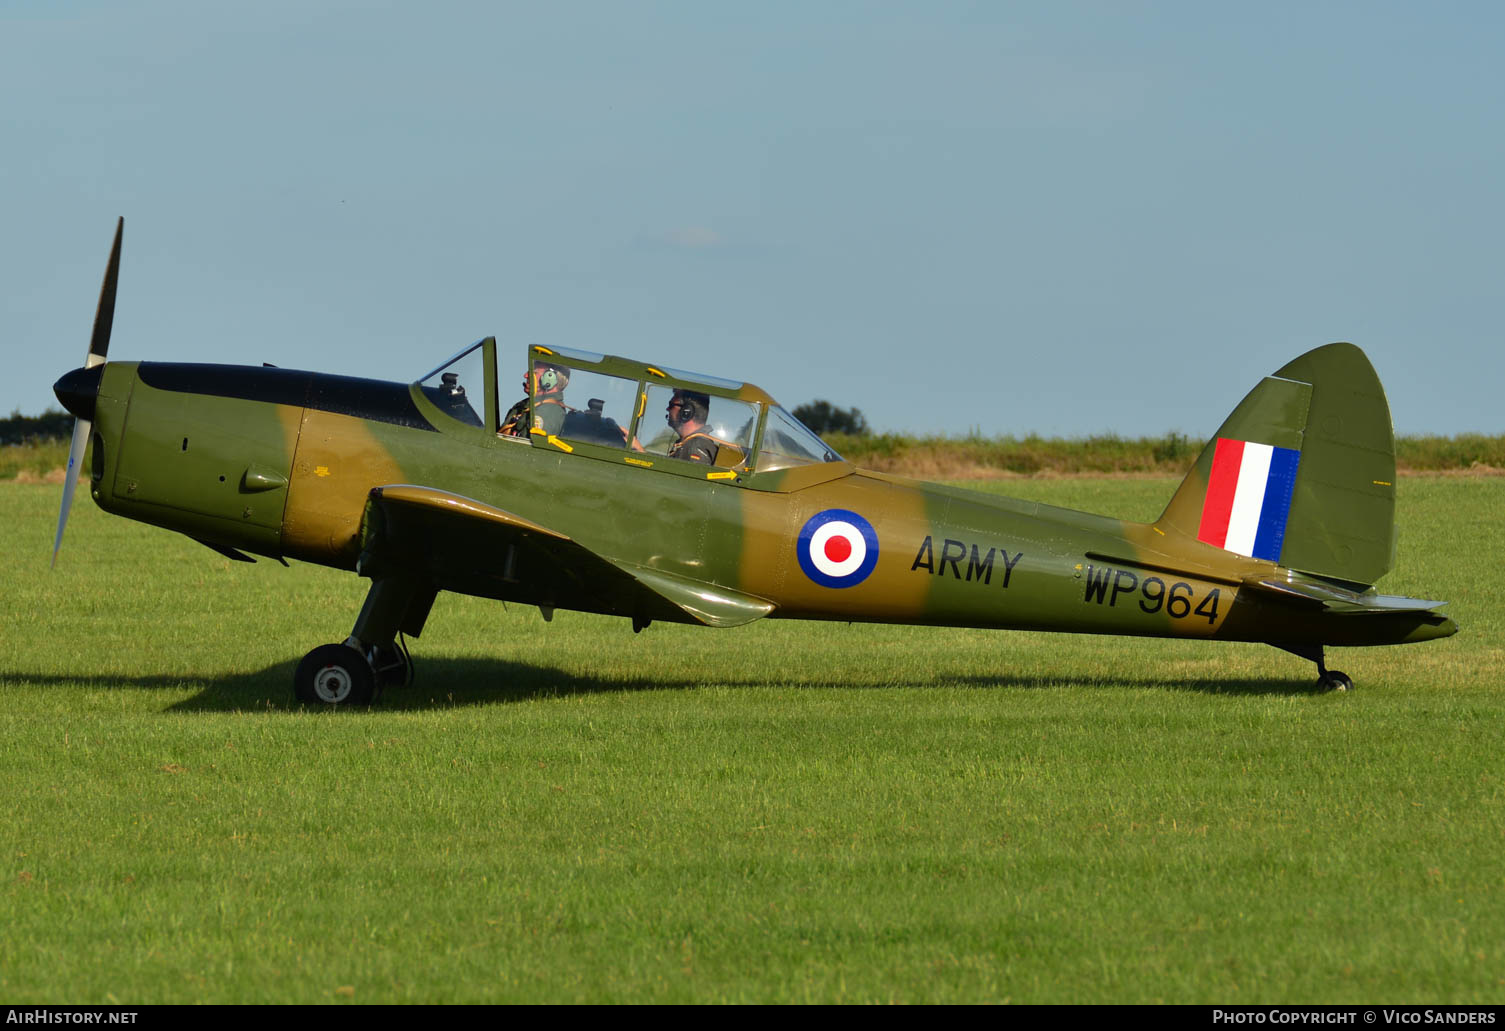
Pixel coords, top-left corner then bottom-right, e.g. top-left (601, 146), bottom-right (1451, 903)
top-left (292, 576), bottom-right (436, 709)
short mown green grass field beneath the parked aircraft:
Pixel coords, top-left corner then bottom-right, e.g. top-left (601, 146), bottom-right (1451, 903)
top-left (0, 477), bottom-right (1505, 1004)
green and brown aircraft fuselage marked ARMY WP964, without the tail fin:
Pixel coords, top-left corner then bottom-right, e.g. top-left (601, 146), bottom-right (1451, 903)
top-left (73, 363), bottom-right (1452, 644)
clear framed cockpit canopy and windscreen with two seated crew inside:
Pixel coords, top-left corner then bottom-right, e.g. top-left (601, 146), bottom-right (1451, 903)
top-left (415, 337), bottom-right (843, 486)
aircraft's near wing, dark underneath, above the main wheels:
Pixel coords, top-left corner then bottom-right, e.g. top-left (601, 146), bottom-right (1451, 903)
top-left (357, 485), bottom-right (774, 626)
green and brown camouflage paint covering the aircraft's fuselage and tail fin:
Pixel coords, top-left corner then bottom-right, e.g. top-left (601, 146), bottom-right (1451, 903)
top-left (67, 340), bottom-right (1455, 656)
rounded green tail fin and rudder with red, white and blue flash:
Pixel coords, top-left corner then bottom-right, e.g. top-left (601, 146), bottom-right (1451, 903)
top-left (1156, 343), bottom-right (1395, 587)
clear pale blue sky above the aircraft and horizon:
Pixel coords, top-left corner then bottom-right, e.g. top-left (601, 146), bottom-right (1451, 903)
top-left (0, 0), bottom-right (1505, 436)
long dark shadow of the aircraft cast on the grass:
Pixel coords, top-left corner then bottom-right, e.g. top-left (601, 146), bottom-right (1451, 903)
top-left (6, 658), bottom-right (1323, 712)
